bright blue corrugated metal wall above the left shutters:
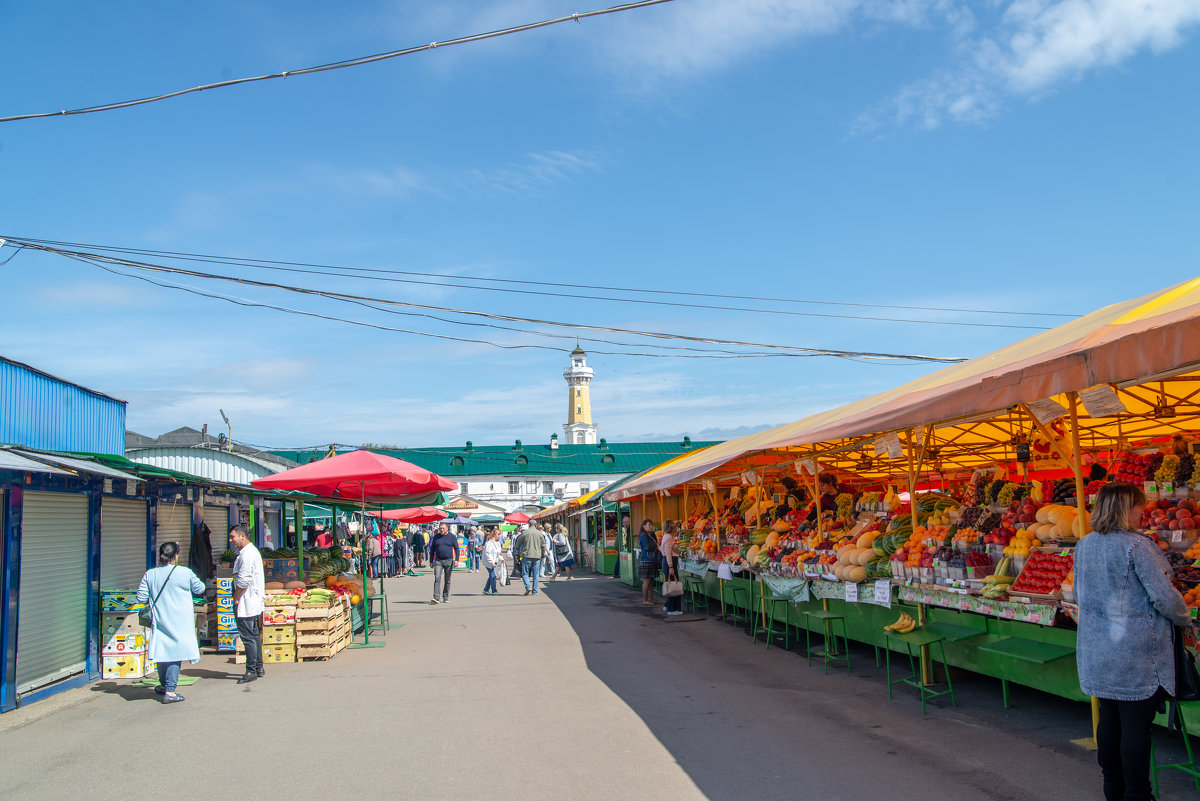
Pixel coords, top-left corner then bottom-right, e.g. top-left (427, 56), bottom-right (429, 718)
top-left (0, 359), bottom-right (125, 456)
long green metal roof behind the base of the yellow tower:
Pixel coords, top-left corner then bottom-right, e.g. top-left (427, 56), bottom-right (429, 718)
top-left (271, 440), bottom-right (715, 478)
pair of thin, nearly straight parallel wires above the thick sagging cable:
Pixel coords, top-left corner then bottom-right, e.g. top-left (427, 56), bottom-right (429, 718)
top-left (9, 232), bottom-right (1080, 323)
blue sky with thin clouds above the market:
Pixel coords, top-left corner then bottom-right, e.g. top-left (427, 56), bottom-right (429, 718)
top-left (0, 0), bottom-right (1200, 447)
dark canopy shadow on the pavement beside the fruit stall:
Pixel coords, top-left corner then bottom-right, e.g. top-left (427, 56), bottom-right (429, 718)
top-left (546, 577), bottom-right (1192, 801)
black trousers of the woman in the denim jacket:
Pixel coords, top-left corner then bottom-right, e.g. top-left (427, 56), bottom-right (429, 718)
top-left (1096, 687), bottom-right (1166, 801)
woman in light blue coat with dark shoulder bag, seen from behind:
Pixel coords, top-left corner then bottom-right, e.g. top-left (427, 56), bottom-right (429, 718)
top-left (138, 542), bottom-right (204, 704)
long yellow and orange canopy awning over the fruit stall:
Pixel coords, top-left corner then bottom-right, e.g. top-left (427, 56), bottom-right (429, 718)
top-left (613, 278), bottom-right (1200, 500)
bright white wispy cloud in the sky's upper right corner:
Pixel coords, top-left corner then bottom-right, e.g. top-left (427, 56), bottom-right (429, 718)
top-left (856, 0), bottom-right (1200, 133)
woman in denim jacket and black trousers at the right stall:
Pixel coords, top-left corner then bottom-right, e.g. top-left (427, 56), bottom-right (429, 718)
top-left (1075, 483), bottom-right (1192, 801)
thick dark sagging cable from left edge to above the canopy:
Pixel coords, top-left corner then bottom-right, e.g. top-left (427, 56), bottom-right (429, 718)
top-left (10, 239), bottom-right (964, 363)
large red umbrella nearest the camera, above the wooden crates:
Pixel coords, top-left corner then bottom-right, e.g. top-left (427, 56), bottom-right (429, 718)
top-left (250, 450), bottom-right (458, 502)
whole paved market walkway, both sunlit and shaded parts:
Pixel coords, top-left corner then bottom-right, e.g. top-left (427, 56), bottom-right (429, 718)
top-left (0, 572), bottom-right (1196, 801)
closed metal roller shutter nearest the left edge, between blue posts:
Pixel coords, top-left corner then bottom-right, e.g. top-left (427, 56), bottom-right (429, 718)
top-left (17, 492), bottom-right (88, 693)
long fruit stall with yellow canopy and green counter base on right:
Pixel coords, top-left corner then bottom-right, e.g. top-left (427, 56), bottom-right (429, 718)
top-left (617, 279), bottom-right (1200, 733)
